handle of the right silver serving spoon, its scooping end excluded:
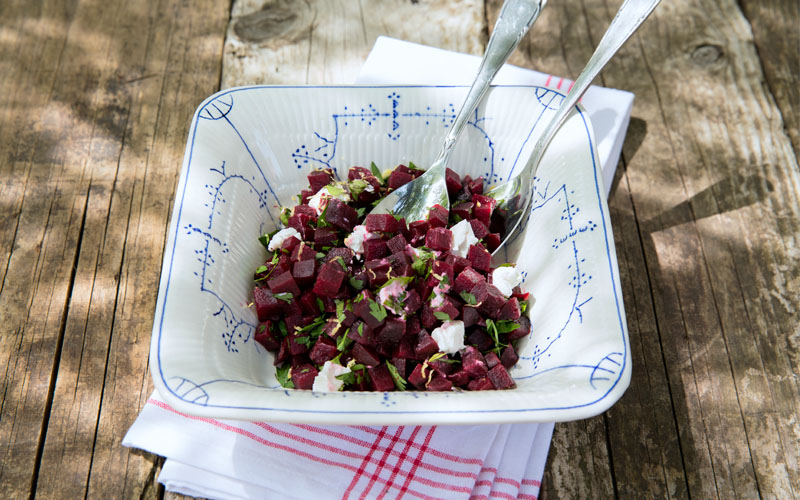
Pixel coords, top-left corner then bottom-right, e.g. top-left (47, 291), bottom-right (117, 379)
top-left (525, 0), bottom-right (661, 182)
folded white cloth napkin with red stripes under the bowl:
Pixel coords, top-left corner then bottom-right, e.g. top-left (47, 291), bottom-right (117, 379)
top-left (122, 37), bottom-right (633, 500)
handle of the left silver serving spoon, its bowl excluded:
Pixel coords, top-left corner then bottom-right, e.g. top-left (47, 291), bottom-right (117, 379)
top-left (432, 0), bottom-right (547, 166)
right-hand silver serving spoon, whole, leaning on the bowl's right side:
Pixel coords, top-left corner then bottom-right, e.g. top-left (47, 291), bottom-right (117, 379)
top-left (486, 0), bottom-right (660, 266)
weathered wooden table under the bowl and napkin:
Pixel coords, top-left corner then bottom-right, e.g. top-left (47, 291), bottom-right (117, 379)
top-left (0, 0), bottom-right (800, 499)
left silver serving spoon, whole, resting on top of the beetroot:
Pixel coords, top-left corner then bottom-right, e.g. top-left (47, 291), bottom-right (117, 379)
top-left (371, 0), bottom-right (547, 222)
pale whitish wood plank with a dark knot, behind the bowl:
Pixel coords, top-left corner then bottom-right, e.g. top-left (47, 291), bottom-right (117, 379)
top-left (222, 0), bottom-right (485, 88)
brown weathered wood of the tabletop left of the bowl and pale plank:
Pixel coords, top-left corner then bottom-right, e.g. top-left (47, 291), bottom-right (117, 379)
top-left (0, 0), bottom-right (229, 498)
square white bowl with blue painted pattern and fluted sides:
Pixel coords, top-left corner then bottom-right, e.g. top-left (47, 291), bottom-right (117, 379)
top-left (150, 86), bottom-right (631, 425)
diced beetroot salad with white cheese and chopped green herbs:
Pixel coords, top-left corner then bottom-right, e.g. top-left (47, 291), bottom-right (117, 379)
top-left (253, 163), bottom-right (531, 391)
